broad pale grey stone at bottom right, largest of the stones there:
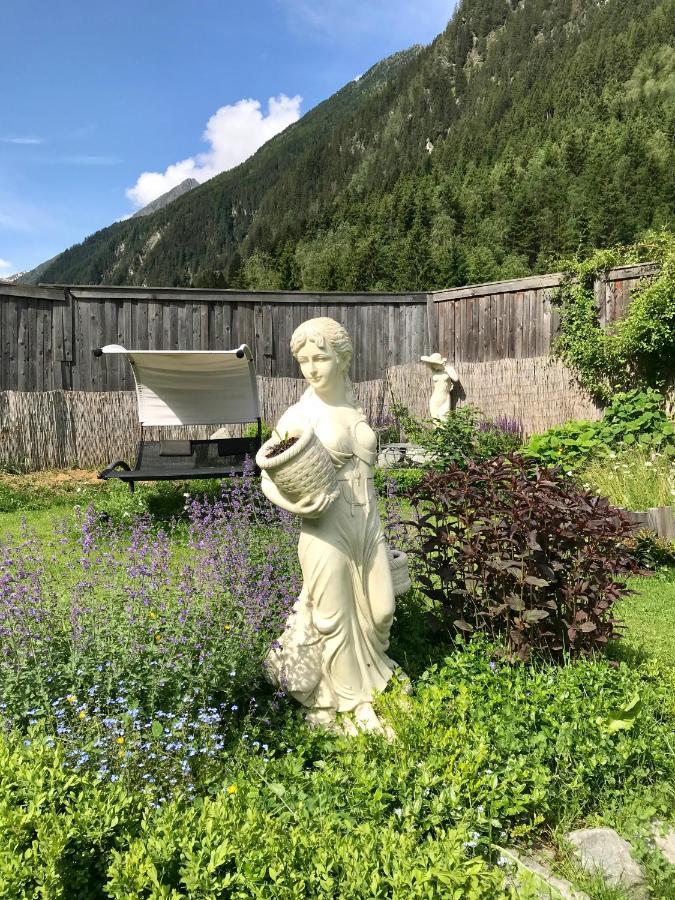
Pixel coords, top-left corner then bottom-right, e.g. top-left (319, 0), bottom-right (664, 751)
top-left (567, 828), bottom-right (649, 900)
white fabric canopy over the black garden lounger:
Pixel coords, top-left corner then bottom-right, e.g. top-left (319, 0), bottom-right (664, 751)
top-left (97, 344), bottom-right (260, 425)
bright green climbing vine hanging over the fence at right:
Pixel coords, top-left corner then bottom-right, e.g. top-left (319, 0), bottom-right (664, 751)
top-left (554, 231), bottom-right (675, 401)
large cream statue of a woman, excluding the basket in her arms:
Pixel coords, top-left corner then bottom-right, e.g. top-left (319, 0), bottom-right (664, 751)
top-left (262, 318), bottom-right (400, 733)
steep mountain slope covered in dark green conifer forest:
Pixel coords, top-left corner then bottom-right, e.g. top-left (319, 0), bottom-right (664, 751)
top-left (38, 0), bottom-right (675, 291)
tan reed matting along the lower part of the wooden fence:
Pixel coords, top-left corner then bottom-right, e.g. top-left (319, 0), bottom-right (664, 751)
top-left (0, 356), bottom-right (600, 471)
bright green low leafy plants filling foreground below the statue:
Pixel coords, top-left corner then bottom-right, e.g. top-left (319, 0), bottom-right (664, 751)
top-left (0, 641), bottom-right (675, 900)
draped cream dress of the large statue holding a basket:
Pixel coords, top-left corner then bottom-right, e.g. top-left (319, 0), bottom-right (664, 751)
top-left (266, 394), bottom-right (396, 712)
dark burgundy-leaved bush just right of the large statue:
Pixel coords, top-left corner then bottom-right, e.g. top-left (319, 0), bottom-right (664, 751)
top-left (411, 455), bottom-right (638, 659)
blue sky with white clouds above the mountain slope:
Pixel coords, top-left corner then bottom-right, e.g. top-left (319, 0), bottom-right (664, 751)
top-left (0, 0), bottom-right (455, 278)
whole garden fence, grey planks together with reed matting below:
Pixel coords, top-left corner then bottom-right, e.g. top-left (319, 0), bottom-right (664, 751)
top-left (0, 265), bottom-right (656, 470)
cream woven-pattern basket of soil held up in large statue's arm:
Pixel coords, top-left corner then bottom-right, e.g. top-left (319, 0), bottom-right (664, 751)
top-left (255, 428), bottom-right (337, 502)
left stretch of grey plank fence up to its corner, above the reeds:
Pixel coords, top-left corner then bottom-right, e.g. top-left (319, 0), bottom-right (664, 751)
top-left (0, 285), bottom-right (429, 391)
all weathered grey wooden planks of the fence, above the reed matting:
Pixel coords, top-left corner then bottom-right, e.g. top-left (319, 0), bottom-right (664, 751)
top-left (0, 266), bottom-right (654, 391)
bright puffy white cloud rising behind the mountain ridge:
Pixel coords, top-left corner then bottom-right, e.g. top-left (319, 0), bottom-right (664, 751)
top-left (126, 94), bottom-right (302, 209)
